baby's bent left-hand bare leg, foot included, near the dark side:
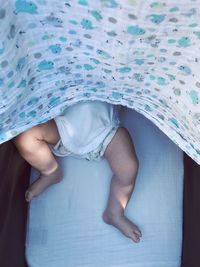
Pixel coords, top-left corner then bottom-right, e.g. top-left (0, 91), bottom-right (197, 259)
top-left (14, 120), bottom-right (62, 201)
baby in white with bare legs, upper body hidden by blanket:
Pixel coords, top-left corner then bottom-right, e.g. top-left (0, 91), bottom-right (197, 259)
top-left (14, 101), bottom-right (141, 242)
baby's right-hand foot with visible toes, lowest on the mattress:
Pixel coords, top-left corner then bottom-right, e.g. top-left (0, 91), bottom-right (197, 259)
top-left (103, 211), bottom-right (142, 243)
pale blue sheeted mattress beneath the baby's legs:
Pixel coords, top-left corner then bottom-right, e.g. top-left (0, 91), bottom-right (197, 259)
top-left (26, 110), bottom-right (183, 267)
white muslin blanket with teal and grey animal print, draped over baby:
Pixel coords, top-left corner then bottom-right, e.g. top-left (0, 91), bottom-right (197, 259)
top-left (0, 0), bottom-right (200, 164)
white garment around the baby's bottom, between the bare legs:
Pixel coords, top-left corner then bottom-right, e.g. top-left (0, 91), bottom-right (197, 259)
top-left (51, 101), bottom-right (120, 160)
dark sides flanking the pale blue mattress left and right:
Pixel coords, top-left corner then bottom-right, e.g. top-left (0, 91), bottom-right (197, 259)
top-left (0, 141), bottom-right (200, 267)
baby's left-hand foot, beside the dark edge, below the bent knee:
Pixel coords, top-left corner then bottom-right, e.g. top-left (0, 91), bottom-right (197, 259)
top-left (25, 167), bottom-right (62, 202)
